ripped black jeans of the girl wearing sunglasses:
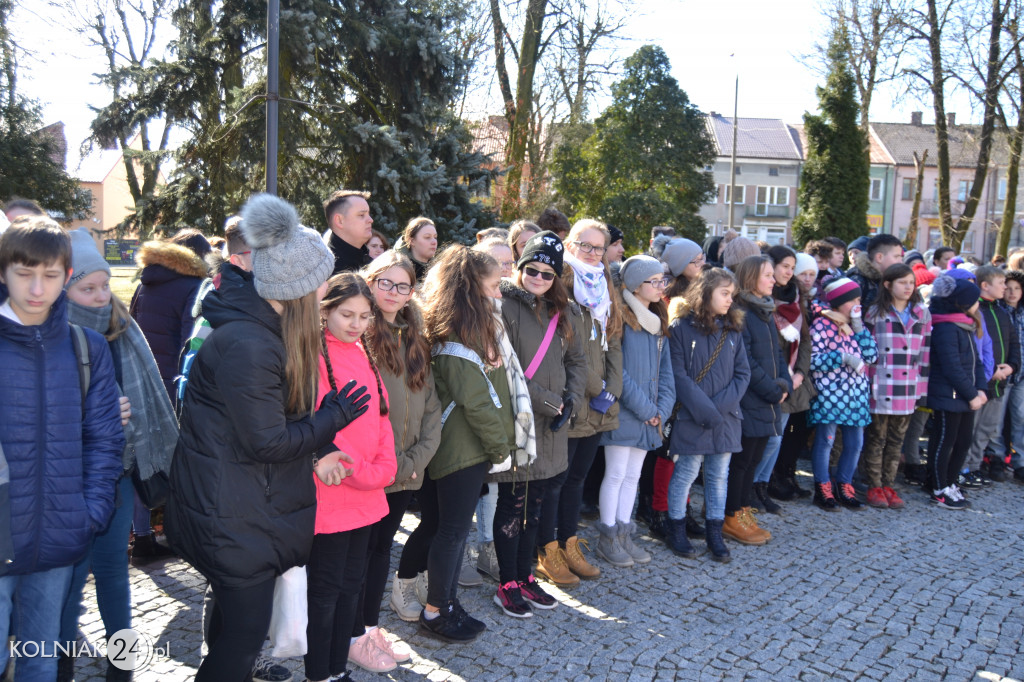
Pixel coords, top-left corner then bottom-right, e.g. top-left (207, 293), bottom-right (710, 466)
top-left (494, 479), bottom-right (550, 585)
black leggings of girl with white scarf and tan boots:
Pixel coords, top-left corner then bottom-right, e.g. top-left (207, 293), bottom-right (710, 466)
top-left (537, 433), bottom-right (601, 547)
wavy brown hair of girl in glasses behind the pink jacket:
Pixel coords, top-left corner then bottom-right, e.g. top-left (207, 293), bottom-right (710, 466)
top-left (361, 251), bottom-right (430, 392)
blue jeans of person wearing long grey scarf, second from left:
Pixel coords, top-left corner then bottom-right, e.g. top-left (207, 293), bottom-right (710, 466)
top-left (60, 476), bottom-right (135, 642)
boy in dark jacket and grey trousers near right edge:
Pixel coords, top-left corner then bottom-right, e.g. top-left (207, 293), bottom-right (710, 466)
top-left (959, 265), bottom-right (1021, 488)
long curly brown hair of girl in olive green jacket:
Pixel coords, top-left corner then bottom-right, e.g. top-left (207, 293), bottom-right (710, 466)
top-left (423, 244), bottom-right (501, 365)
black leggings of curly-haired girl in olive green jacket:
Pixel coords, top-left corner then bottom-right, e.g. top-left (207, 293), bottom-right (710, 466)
top-left (398, 462), bottom-right (490, 608)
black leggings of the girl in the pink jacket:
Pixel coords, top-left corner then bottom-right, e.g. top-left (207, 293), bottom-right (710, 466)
top-left (304, 525), bottom-right (371, 680)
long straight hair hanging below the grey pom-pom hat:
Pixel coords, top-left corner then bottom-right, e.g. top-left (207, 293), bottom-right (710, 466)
top-left (278, 291), bottom-right (321, 414)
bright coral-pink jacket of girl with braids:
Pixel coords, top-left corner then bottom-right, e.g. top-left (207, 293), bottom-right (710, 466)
top-left (313, 332), bottom-right (398, 534)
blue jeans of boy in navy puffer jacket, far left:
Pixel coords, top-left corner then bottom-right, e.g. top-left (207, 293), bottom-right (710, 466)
top-left (0, 566), bottom-right (73, 682)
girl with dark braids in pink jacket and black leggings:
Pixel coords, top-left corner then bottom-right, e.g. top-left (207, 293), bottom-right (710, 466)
top-left (305, 272), bottom-right (397, 681)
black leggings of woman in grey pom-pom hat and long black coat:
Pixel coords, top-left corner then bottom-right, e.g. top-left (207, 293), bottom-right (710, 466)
top-left (196, 578), bottom-right (274, 682)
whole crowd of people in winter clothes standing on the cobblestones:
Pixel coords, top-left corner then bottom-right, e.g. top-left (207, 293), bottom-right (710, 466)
top-left (0, 190), bottom-right (1024, 682)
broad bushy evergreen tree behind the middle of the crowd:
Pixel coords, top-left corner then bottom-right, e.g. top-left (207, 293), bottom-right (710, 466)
top-left (554, 45), bottom-right (715, 245)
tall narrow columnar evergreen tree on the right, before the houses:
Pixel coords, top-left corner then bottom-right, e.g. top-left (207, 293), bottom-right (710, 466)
top-left (793, 27), bottom-right (870, 249)
